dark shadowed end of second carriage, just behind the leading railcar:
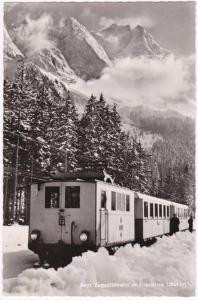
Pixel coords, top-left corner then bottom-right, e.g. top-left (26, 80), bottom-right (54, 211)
top-left (134, 193), bottom-right (143, 241)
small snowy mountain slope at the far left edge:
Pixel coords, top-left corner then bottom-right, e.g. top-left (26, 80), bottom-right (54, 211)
top-left (3, 27), bottom-right (24, 61)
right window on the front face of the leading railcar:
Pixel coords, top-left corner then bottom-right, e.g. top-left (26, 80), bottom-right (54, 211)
top-left (65, 186), bottom-right (80, 208)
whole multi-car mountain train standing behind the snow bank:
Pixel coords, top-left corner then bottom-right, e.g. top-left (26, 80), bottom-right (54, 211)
top-left (28, 173), bottom-right (189, 264)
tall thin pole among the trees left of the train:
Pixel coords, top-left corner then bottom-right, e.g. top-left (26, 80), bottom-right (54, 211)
top-left (11, 110), bottom-right (21, 220)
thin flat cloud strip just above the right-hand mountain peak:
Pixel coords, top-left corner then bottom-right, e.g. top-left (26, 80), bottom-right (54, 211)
top-left (99, 16), bottom-right (154, 29)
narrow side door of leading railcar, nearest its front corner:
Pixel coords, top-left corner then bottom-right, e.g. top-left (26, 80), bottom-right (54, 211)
top-left (100, 191), bottom-right (108, 246)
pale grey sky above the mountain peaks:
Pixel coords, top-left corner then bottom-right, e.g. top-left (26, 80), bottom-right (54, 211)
top-left (5, 2), bottom-right (195, 55)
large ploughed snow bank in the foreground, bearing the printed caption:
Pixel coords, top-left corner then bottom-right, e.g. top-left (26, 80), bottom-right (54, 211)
top-left (4, 232), bottom-right (195, 296)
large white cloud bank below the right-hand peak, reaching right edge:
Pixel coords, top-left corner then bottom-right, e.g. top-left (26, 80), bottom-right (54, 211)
top-left (72, 55), bottom-right (195, 115)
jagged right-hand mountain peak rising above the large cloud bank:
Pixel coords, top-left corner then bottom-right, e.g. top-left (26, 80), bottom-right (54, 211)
top-left (94, 24), bottom-right (170, 58)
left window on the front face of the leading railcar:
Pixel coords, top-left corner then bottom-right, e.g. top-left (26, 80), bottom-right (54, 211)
top-left (45, 186), bottom-right (60, 208)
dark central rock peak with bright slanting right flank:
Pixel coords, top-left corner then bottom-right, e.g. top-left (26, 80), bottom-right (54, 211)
top-left (50, 18), bottom-right (111, 80)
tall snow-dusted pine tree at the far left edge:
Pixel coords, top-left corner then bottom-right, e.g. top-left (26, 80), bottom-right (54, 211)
top-left (4, 63), bottom-right (38, 221)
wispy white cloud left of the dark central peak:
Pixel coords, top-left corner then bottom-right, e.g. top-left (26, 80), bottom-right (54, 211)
top-left (17, 14), bottom-right (54, 55)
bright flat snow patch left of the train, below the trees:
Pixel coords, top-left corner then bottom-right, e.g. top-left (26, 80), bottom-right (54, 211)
top-left (3, 224), bottom-right (29, 253)
